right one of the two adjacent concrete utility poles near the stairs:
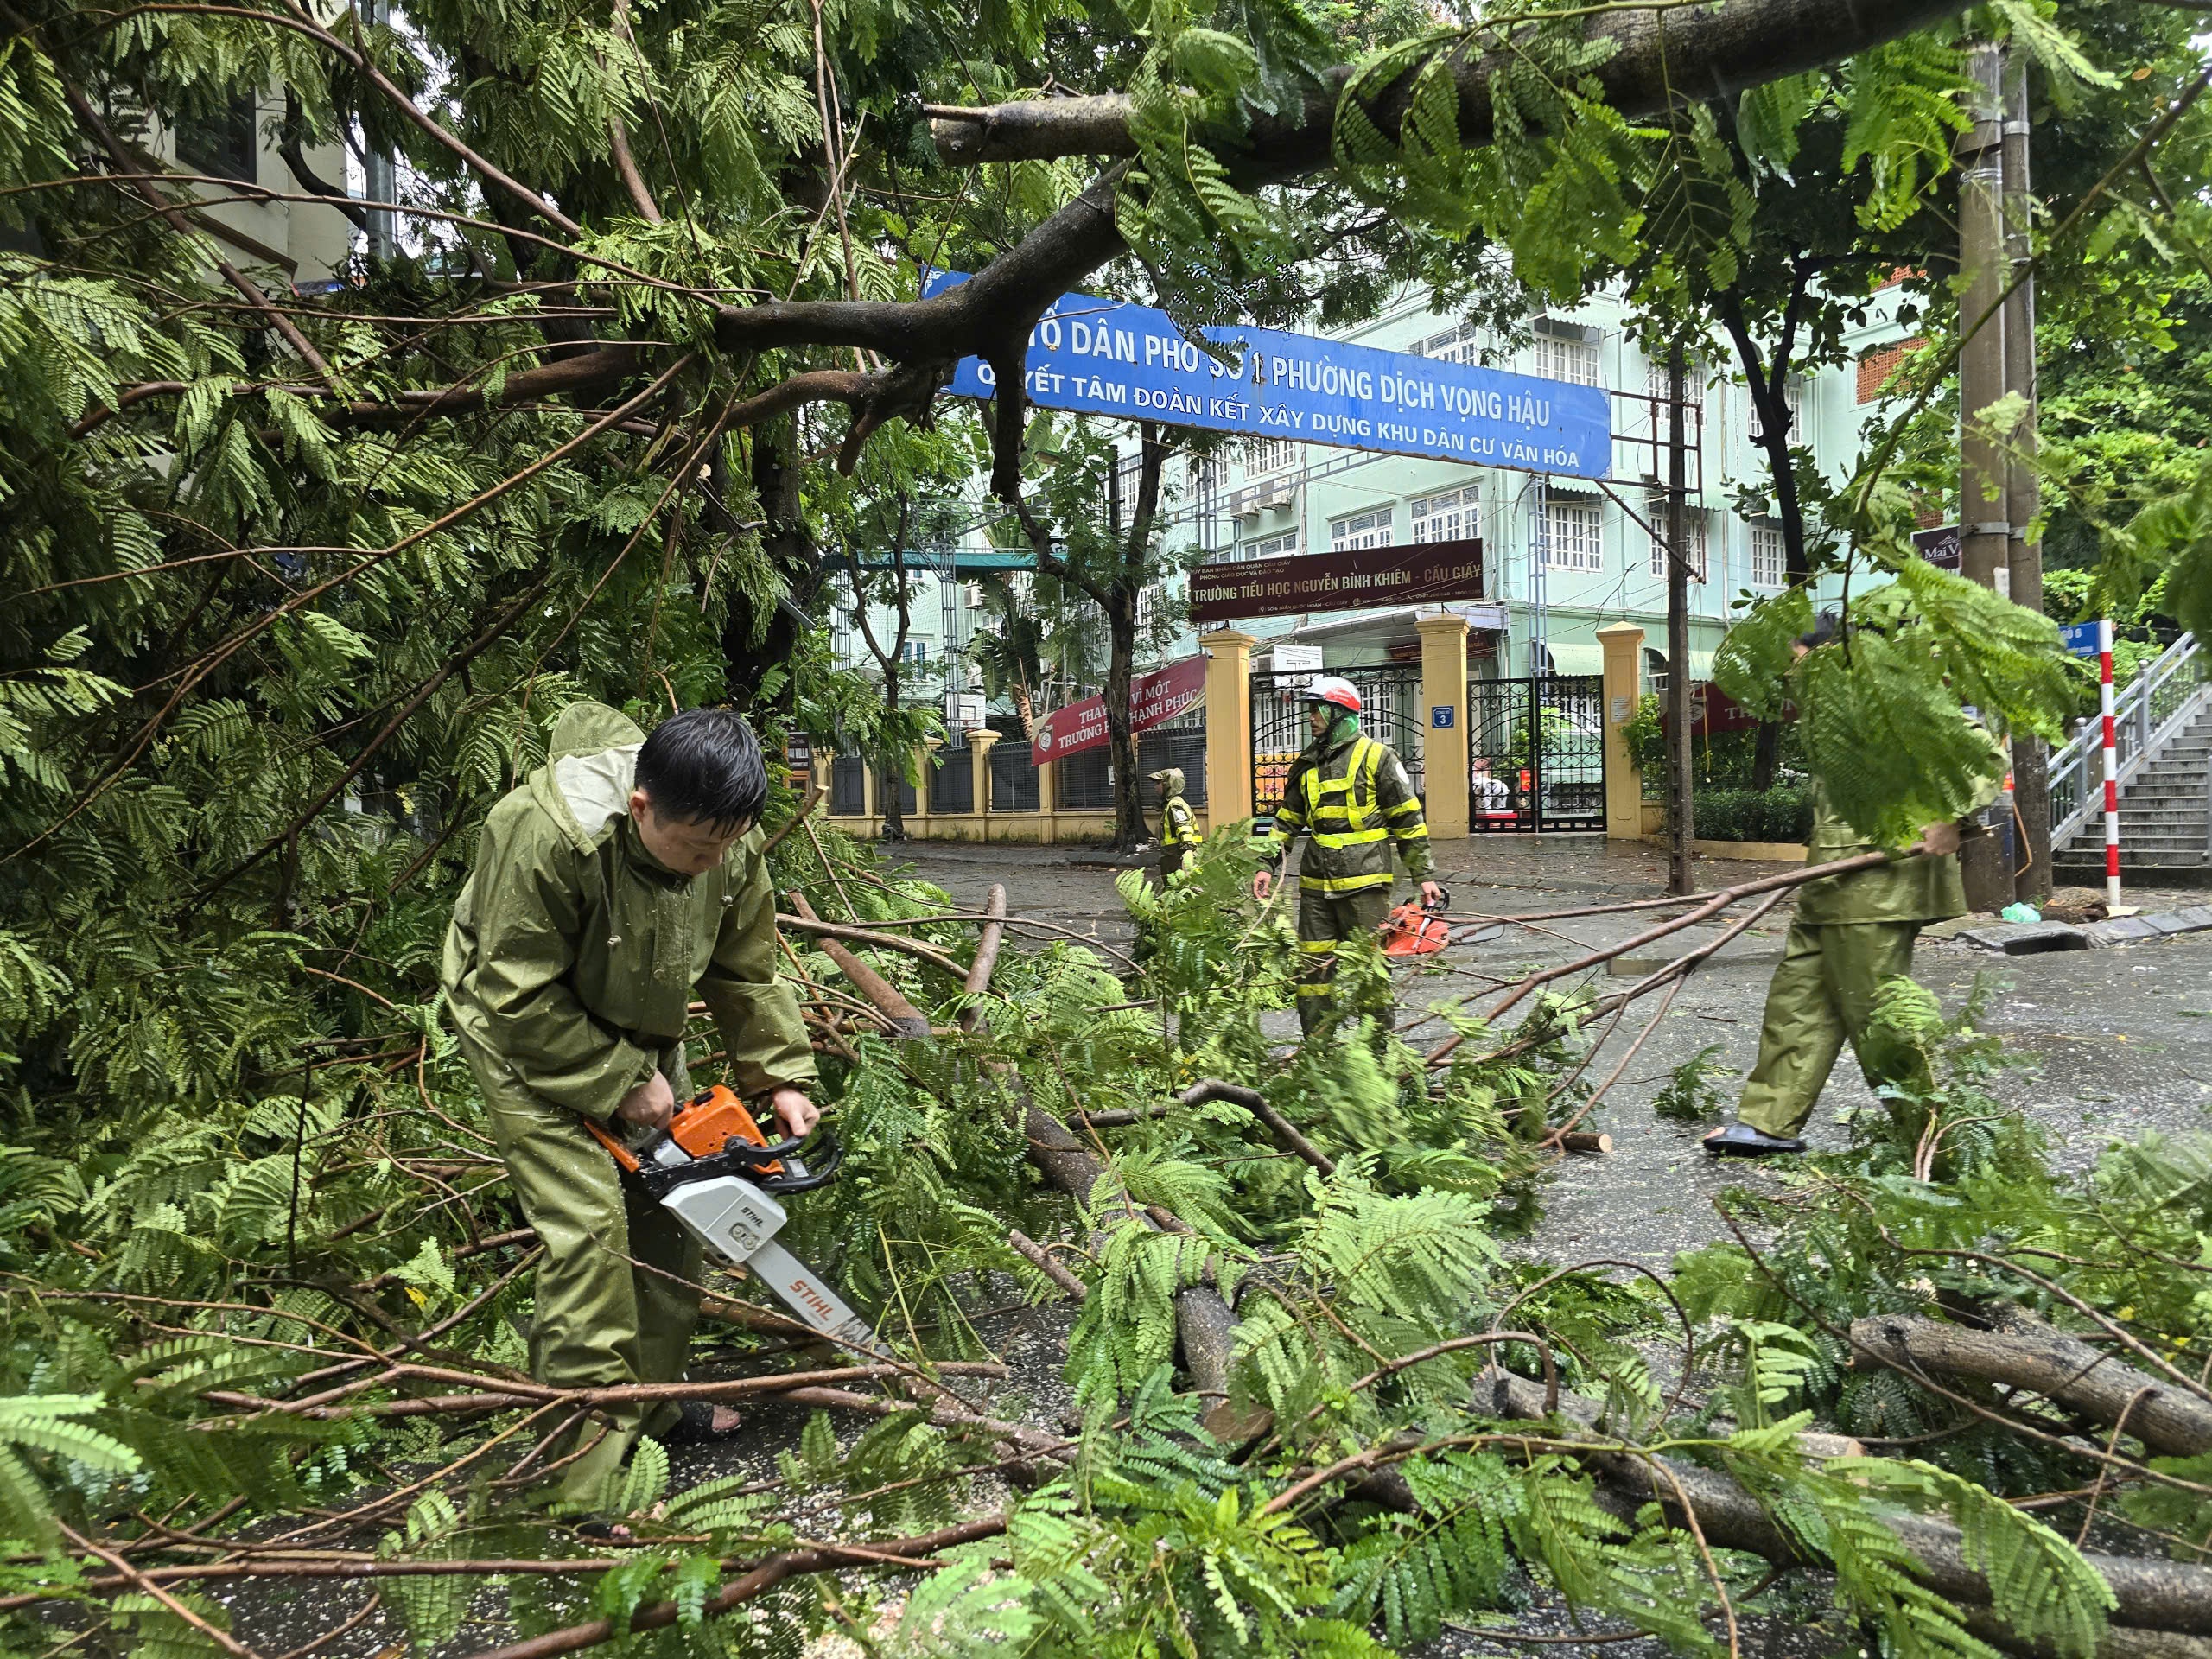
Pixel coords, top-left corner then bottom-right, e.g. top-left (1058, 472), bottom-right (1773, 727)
top-left (2004, 48), bottom-right (2050, 905)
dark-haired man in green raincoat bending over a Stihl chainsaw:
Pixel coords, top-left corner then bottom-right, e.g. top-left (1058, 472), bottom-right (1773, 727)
top-left (442, 703), bottom-right (817, 1510)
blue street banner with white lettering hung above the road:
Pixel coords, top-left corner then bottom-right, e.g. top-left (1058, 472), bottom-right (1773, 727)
top-left (923, 272), bottom-right (1612, 478)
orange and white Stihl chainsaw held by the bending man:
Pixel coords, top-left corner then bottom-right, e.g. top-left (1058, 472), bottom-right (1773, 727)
top-left (588, 1086), bottom-right (882, 1356)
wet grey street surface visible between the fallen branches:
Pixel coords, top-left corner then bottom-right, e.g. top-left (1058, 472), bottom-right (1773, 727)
top-left (885, 836), bottom-right (2212, 1265)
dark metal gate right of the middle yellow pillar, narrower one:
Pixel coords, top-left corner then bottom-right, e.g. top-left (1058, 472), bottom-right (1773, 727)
top-left (1466, 675), bottom-right (1606, 834)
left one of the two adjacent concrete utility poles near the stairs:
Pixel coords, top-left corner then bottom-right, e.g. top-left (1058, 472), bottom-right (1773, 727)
top-left (1953, 42), bottom-right (2013, 912)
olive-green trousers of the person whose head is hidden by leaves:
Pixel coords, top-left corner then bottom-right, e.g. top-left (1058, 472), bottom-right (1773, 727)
top-left (1737, 923), bottom-right (1929, 1139)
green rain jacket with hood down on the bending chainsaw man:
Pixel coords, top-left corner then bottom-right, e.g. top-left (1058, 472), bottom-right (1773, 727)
top-left (440, 703), bottom-right (814, 1119)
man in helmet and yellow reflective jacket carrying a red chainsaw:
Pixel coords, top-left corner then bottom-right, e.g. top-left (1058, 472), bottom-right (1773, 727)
top-left (1252, 675), bottom-right (1445, 1031)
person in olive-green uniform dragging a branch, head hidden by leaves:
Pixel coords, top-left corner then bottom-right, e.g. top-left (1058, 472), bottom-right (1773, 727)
top-left (1706, 617), bottom-right (2002, 1157)
